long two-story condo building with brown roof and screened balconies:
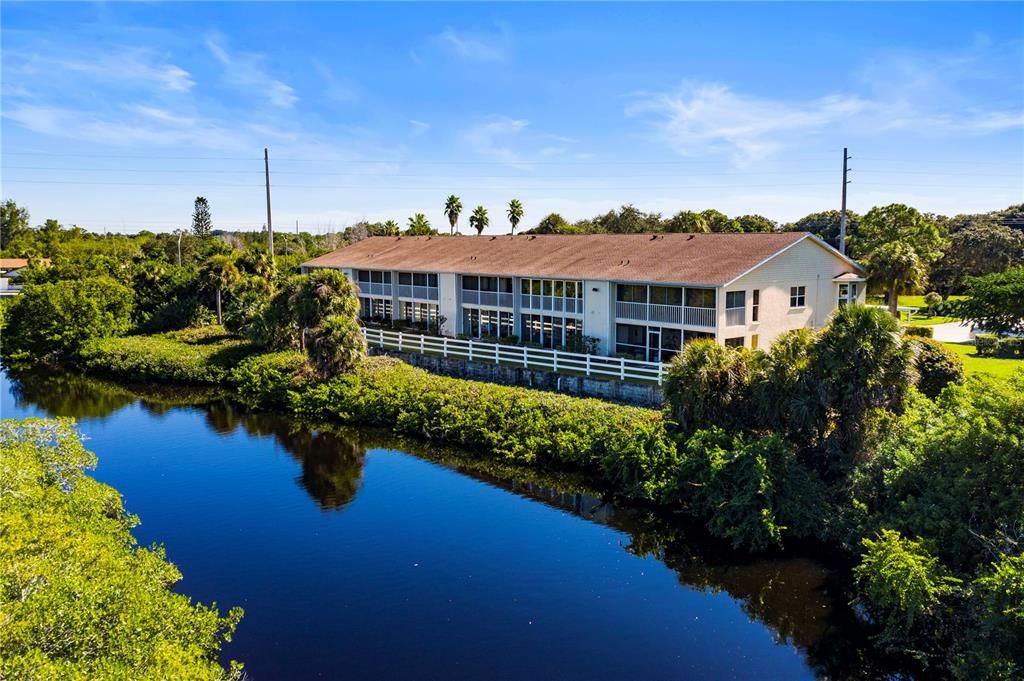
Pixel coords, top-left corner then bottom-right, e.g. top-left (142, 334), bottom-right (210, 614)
top-left (303, 232), bottom-right (865, 361)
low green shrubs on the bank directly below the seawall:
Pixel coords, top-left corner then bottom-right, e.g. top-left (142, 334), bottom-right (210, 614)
top-left (291, 357), bottom-right (674, 481)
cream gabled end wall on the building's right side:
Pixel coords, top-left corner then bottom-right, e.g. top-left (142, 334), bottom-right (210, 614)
top-left (718, 239), bottom-right (866, 349)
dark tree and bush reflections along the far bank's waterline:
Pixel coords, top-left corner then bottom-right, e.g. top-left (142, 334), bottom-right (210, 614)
top-left (4, 368), bottom-right (907, 679)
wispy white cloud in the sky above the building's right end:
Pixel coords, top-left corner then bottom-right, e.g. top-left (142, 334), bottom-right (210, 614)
top-left (626, 44), bottom-right (1024, 165)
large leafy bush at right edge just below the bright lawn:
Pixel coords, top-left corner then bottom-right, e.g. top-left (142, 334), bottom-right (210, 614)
top-left (850, 373), bottom-right (1024, 574)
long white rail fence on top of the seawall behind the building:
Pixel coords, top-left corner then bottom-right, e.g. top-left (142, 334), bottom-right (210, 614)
top-left (362, 327), bottom-right (666, 385)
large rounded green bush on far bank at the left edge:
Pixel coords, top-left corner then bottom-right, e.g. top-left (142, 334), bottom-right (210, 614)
top-left (3, 276), bottom-right (133, 366)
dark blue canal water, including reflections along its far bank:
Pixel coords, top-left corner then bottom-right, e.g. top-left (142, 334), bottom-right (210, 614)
top-left (2, 375), bottom-right (898, 679)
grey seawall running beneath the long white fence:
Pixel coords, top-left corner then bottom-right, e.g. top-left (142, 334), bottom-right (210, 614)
top-left (370, 347), bottom-right (664, 409)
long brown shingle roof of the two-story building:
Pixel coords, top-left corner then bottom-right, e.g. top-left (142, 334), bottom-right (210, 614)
top-left (304, 231), bottom-right (839, 286)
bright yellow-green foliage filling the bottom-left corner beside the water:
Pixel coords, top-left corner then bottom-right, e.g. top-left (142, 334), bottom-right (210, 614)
top-left (0, 419), bottom-right (242, 680)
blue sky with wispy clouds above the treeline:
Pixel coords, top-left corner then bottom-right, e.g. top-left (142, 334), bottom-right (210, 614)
top-left (0, 2), bottom-right (1024, 232)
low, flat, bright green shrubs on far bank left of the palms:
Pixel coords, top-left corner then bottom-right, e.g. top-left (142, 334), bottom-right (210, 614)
top-left (82, 326), bottom-right (254, 384)
